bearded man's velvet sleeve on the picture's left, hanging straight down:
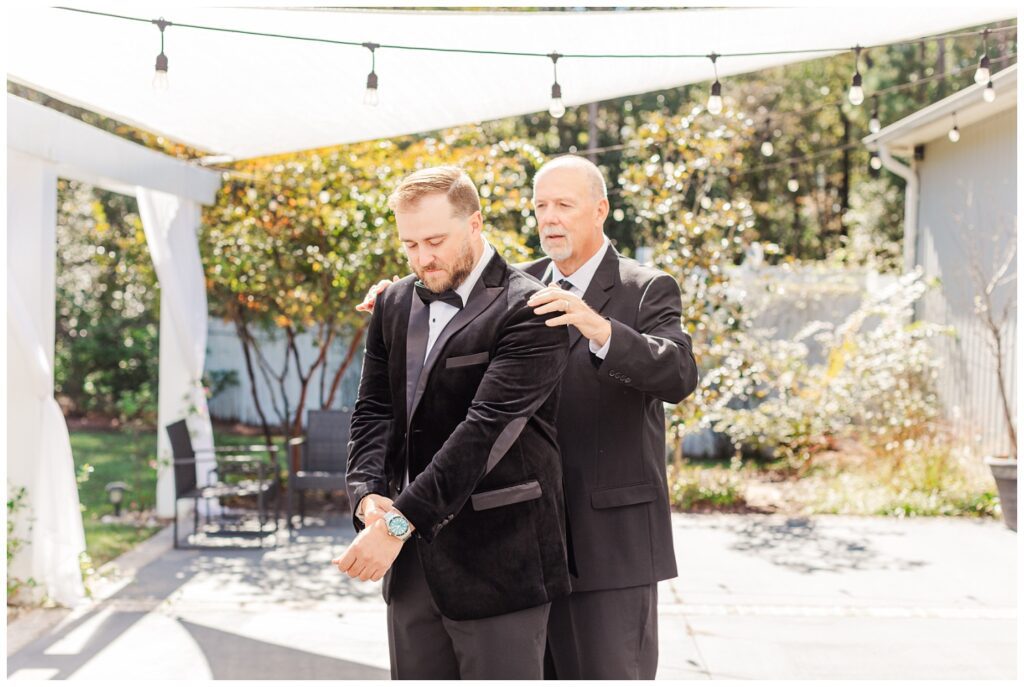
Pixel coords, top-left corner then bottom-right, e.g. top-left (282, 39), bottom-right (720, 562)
top-left (346, 290), bottom-right (394, 531)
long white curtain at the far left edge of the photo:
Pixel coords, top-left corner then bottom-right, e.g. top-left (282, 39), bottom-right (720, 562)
top-left (5, 147), bottom-right (85, 606)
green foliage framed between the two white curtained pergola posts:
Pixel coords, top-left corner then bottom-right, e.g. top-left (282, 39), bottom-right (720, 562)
top-left (54, 179), bottom-right (160, 422)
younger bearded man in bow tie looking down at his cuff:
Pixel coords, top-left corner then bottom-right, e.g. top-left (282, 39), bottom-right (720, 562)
top-left (335, 168), bottom-right (569, 679)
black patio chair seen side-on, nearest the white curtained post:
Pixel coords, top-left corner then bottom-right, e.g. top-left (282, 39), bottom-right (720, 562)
top-left (166, 420), bottom-right (281, 549)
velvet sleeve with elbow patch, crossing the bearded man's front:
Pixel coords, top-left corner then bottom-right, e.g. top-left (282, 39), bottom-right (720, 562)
top-left (394, 303), bottom-right (568, 542)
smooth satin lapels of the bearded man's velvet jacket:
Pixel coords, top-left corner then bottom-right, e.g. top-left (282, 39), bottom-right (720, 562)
top-left (406, 253), bottom-right (508, 428)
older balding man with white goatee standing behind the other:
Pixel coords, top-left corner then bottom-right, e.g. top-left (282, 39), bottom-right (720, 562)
top-left (521, 156), bottom-right (697, 680)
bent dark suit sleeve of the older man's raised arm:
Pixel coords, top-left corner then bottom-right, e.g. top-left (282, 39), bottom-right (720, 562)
top-left (594, 274), bottom-right (697, 403)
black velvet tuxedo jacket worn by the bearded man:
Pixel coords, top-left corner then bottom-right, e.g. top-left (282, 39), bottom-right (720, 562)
top-left (348, 254), bottom-right (569, 619)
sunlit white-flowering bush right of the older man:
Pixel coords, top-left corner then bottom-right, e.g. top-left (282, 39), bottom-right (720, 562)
top-left (680, 271), bottom-right (949, 468)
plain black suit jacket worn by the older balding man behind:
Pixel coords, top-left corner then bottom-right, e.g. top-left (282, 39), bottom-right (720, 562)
top-left (521, 247), bottom-right (697, 591)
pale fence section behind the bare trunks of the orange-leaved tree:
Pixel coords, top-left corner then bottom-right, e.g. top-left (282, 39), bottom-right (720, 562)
top-left (206, 317), bottom-right (362, 425)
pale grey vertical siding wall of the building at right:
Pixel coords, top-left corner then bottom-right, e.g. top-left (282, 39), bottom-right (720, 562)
top-left (915, 108), bottom-right (1017, 453)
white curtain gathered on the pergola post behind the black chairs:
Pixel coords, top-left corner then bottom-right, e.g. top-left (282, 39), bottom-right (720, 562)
top-left (136, 187), bottom-right (213, 517)
